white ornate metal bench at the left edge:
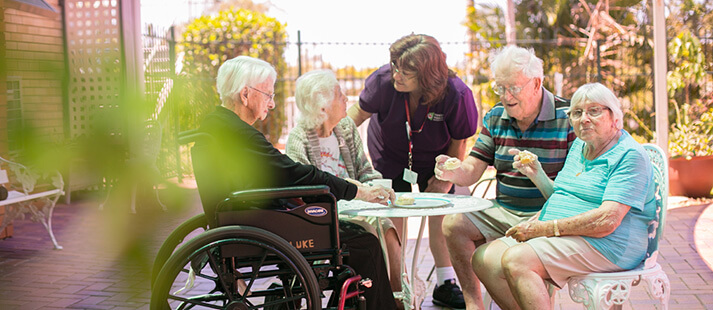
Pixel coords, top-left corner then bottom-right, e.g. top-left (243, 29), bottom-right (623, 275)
top-left (0, 157), bottom-right (64, 250)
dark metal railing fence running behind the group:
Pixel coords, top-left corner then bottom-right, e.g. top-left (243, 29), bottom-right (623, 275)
top-left (144, 27), bottom-right (713, 177)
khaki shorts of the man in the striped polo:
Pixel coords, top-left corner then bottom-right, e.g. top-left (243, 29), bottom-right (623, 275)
top-left (465, 200), bottom-right (537, 242)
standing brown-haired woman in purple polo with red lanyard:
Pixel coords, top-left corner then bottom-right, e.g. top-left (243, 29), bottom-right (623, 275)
top-left (347, 34), bottom-right (478, 308)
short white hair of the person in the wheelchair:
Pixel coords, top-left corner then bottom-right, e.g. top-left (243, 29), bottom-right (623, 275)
top-left (216, 56), bottom-right (277, 109)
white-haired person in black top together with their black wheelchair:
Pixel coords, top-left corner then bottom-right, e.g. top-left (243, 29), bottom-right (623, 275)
top-left (151, 56), bottom-right (396, 309)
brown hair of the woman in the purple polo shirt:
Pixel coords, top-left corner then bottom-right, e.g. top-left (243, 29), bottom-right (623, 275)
top-left (389, 34), bottom-right (455, 106)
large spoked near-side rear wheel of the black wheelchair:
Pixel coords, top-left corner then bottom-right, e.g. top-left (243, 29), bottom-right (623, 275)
top-left (151, 226), bottom-right (322, 310)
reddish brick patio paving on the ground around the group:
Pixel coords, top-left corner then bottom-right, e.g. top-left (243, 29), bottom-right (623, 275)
top-left (0, 186), bottom-right (713, 310)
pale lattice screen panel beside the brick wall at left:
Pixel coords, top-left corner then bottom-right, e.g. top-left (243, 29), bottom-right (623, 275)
top-left (65, 0), bottom-right (124, 138)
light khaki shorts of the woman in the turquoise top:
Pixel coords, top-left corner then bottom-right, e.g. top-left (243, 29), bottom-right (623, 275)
top-left (498, 236), bottom-right (622, 288)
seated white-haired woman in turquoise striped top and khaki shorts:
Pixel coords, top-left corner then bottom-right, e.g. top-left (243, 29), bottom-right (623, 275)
top-left (473, 83), bottom-right (656, 309)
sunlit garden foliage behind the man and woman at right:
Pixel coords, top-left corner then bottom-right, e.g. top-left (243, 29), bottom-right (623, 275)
top-left (467, 0), bottom-right (713, 142)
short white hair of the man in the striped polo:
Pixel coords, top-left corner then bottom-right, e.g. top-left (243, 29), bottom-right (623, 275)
top-left (490, 45), bottom-right (544, 81)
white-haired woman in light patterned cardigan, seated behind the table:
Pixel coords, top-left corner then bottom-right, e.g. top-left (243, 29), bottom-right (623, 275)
top-left (286, 70), bottom-right (401, 291)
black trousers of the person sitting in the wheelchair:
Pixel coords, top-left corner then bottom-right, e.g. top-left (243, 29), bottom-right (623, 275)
top-left (333, 221), bottom-right (396, 310)
